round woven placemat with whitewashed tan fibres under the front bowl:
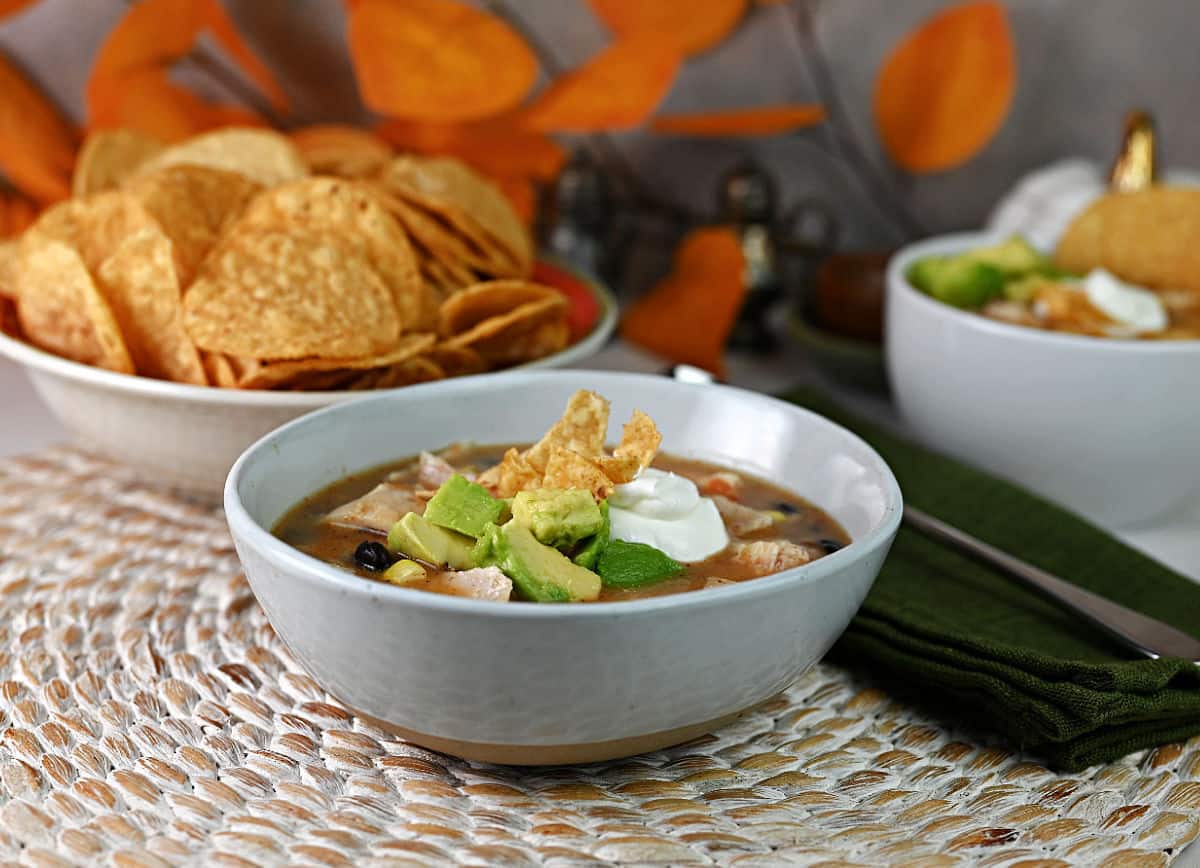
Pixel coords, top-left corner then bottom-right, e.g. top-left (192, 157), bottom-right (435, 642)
top-left (0, 449), bottom-right (1200, 867)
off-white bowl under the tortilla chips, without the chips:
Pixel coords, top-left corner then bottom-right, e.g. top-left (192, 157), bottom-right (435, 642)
top-left (0, 263), bottom-right (617, 503)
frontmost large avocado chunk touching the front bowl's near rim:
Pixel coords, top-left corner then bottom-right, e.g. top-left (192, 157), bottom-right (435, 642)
top-left (473, 521), bottom-right (600, 603)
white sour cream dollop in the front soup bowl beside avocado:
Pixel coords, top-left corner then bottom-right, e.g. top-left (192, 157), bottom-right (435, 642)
top-left (608, 467), bottom-right (730, 563)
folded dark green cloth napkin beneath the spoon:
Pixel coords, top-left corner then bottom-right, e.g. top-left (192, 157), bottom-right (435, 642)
top-left (787, 390), bottom-right (1200, 771)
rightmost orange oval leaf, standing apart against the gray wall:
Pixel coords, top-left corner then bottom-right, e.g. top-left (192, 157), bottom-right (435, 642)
top-left (875, 0), bottom-right (1016, 172)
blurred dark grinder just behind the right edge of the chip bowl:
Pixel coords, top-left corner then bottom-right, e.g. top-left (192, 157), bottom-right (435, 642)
top-left (538, 151), bottom-right (613, 282)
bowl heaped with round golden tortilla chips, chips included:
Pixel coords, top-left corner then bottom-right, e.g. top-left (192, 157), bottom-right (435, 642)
top-left (0, 128), bottom-right (617, 497)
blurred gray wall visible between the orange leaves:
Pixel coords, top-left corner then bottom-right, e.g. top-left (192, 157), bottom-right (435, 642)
top-left (0, 0), bottom-right (1200, 249)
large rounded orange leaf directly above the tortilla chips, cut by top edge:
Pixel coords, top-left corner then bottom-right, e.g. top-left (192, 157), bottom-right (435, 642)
top-left (347, 0), bottom-right (538, 121)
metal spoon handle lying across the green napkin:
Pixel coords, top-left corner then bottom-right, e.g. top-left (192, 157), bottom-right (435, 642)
top-left (904, 505), bottom-right (1200, 662)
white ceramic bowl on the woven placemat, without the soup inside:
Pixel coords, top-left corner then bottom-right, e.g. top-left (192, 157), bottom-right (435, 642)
top-left (224, 371), bottom-right (901, 764)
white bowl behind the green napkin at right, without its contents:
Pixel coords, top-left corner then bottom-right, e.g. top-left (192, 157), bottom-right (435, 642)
top-left (886, 233), bottom-right (1200, 526)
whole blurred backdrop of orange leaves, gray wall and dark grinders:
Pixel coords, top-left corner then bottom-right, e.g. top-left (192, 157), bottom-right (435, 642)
top-left (0, 0), bottom-right (1200, 390)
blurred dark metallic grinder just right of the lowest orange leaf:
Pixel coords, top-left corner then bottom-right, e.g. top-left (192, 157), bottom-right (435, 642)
top-left (719, 160), bottom-right (784, 354)
